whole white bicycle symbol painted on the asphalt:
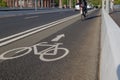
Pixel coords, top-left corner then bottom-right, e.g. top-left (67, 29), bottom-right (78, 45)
top-left (0, 42), bottom-right (69, 62)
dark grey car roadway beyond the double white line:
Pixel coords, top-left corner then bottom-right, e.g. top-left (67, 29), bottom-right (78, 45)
top-left (0, 10), bottom-right (78, 38)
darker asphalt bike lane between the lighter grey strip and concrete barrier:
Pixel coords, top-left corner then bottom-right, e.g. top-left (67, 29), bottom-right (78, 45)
top-left (0, 9), bottom-right (100, 80)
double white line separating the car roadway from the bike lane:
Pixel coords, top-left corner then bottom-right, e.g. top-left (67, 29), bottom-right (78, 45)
top-left (0, 14), bottom-right (80, 46)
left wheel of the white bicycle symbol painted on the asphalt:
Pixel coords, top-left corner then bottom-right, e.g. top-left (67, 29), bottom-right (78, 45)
top-left (0, 47), bottom-right (32, 60)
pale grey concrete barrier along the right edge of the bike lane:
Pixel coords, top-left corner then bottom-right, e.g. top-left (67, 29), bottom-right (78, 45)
top-left (100, 10), bottom-right (120, 80)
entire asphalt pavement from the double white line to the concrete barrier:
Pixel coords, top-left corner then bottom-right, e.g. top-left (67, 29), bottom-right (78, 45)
top-left (0, 10), bottom-right (100, 80)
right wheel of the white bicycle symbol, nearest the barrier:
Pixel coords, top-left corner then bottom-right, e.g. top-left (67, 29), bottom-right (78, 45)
top-left (39, 48), bottom-right (69, 62)
